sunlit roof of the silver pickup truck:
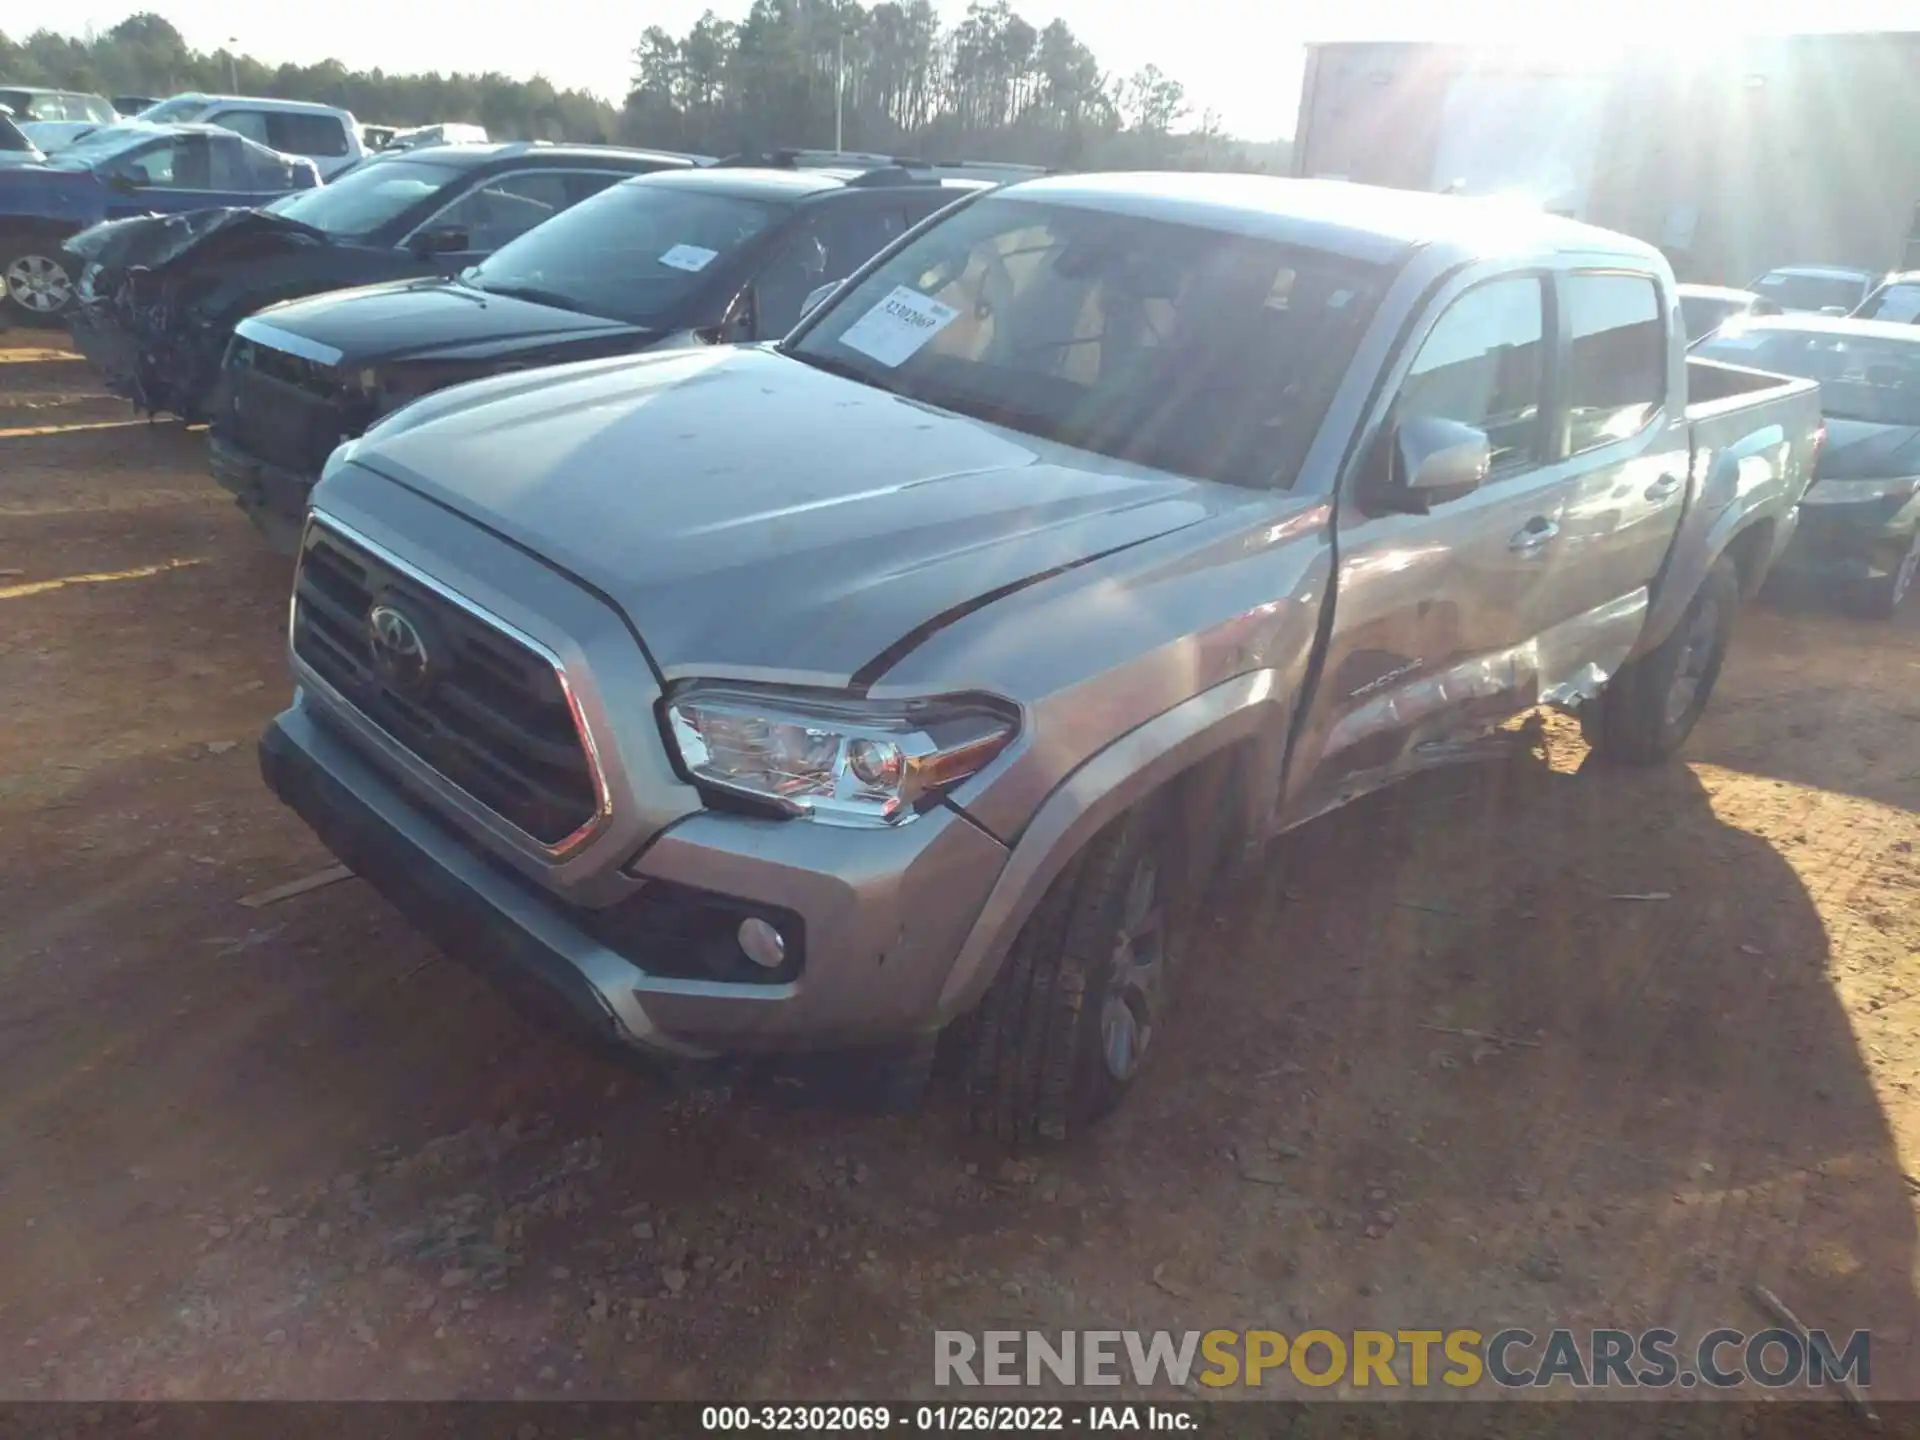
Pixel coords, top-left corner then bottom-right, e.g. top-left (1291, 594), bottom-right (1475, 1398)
top-left (1006, 171), bottom-right (1659, 261)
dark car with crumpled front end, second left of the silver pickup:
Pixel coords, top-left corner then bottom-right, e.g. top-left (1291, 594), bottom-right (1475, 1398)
top-left (67, 142), bottom-right (693, 420)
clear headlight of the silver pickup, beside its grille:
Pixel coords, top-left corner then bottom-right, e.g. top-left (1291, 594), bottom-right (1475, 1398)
top-left (666, 684), bottom-right (1016, 826)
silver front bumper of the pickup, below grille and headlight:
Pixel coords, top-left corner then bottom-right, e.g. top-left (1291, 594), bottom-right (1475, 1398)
top-left (259, 693), bottom-right (1006, 1060)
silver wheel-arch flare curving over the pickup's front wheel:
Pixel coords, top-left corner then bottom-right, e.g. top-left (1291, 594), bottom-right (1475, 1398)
top-left (939, 670), bottom-right (1292, 1025)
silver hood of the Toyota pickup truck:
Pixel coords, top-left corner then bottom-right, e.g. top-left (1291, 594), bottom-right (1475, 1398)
top-left (343, 348), bottom-right (1228, 685)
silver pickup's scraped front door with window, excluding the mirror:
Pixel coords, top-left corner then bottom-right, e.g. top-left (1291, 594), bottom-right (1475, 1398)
top-left (1279, 267), bottom-right (1569, 826)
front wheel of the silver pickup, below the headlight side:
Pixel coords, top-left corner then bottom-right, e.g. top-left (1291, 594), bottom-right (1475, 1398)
top-left (964, 808), bottom-right (1175, 1150)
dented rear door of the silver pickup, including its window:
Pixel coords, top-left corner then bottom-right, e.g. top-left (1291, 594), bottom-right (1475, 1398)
top-left (1542, 261), bottom-right (1690, 687)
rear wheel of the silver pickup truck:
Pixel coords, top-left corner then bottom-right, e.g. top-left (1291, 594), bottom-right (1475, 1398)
top-left (1580, 557), bottom-right (1740, 764)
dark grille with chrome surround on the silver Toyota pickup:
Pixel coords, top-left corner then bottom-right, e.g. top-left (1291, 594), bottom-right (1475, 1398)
top-left (294, 522), bottom-right (599, 845)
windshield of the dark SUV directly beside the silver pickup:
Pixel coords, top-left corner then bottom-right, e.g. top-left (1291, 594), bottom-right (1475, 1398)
top-left (465, 180), bottom-right (787, 324)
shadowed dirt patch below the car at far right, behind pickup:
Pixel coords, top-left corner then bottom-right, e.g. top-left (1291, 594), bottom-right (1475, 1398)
top-left (1686, 595), bottom-right (1920, 810)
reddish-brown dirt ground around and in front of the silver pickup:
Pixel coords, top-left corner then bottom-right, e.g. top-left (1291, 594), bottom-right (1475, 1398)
top-left (0, 332), bottom-right (1920, 1398)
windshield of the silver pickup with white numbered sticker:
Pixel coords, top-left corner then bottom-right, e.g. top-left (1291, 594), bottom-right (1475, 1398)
top-left (789, 196), bottom-right (1390, 486)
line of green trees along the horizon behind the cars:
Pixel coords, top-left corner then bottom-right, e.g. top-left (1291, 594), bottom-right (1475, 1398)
top-left (0, 0), bottom-right (1284, 169)
